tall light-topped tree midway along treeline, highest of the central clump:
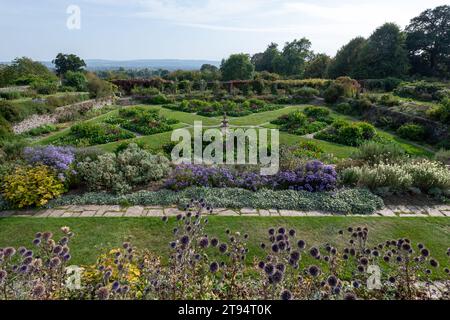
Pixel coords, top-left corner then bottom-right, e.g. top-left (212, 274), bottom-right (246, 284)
top-left (275, 38), bottom-right (312, 77)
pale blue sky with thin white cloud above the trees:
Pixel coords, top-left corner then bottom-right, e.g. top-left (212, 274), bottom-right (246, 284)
top-left (0, 0), bottom-right (450, 61)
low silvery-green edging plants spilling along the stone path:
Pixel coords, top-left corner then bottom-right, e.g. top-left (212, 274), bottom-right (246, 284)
top-left (37, 187), bottom-right (384, 214)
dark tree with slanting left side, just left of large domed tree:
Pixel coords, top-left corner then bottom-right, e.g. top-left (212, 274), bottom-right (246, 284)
top-left (328, 37), bottom-right (366, 79)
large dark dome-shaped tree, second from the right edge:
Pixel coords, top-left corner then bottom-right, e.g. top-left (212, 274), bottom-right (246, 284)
top-left (353, 23), bottom-right (409, 79)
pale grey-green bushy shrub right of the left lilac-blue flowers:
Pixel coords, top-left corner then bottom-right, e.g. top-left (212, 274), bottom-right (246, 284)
top-left (77, 144), bottom-right (170, 193)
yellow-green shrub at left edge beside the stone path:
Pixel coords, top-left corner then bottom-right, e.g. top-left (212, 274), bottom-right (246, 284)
top-left (2, 165), bottom-right (66, 208)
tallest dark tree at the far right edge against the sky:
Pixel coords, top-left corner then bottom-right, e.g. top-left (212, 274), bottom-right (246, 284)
top-left (406, 5), bottom-right (450, 79)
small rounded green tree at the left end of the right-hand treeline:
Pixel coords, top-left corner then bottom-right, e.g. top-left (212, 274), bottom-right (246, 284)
top-left (220, 53), bottom-right (254, 81)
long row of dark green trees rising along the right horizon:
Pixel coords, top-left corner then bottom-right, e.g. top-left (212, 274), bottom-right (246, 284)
top-left (232, 5), bottom-right (450, 80)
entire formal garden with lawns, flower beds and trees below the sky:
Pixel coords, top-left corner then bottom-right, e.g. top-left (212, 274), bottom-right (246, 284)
top-left (0, 6), bottom-right (450, 300)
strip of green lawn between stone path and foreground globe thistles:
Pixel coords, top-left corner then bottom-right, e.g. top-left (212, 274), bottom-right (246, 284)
top-left (0, 217), bottom-right (450, 276)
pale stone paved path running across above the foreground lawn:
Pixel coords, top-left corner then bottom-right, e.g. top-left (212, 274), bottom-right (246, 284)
top-left (0, 205), bottom-right (450, 218)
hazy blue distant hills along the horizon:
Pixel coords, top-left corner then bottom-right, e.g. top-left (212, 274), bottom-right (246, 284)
top-left (38, 59), bottom-right (220, 71)
